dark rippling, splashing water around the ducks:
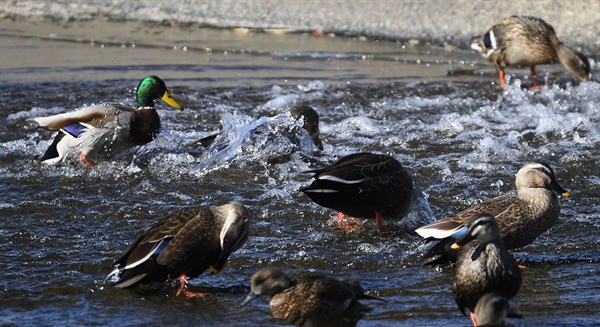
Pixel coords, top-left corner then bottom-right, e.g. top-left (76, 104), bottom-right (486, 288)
top-left (0, 20), bottom-right (600, 326)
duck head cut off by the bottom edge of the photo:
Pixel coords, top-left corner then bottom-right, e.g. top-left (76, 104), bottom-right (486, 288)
top-left (475, 292), bottom-right (521, 327)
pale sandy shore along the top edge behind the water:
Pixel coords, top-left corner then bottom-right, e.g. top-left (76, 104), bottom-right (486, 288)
top-left (0, 0), bottom-right (600, 51)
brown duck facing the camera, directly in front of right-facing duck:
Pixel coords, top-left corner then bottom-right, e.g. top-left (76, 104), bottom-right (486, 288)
top-left (452, 213), bottom-right (521, 327)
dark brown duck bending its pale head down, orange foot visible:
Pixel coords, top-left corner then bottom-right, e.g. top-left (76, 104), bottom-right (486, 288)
top-left (105, 202), bottom-right (250, 297)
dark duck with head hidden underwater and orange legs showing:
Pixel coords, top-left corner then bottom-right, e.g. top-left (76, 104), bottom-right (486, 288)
top-left (300, 153), bottom-right (416, 231)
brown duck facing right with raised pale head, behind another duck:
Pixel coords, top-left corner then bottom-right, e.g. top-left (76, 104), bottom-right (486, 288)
top-left (415, 162), bottom-right (571, 265)
